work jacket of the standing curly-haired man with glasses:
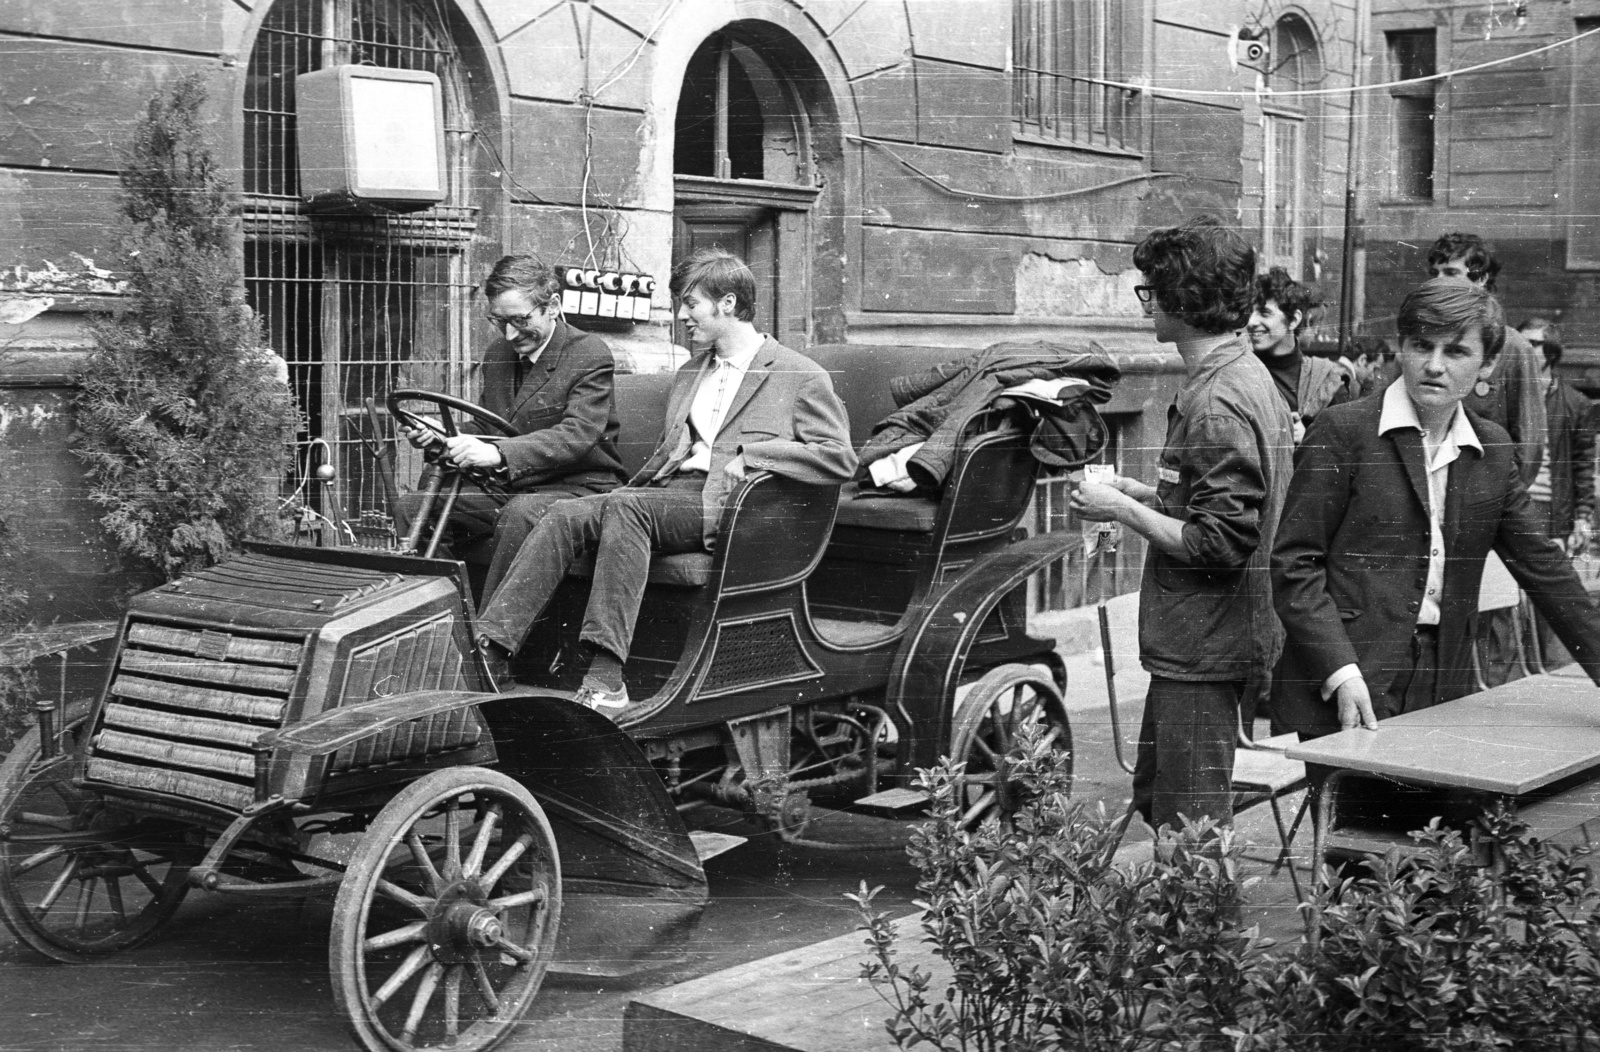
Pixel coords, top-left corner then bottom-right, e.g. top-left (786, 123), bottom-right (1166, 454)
top-left (1139, 337), bottom-right (1294, 679)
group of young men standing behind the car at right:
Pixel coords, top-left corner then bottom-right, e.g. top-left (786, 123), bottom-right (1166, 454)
top-left (1074, 219), bottom-right (1600, 828)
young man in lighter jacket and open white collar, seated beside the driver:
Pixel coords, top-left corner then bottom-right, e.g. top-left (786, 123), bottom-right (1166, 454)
top-left (480, 249), bottom-right (856, 713)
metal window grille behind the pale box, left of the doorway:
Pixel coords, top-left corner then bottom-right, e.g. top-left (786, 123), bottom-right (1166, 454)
top-left (243, 0), bottom-right (478, 515)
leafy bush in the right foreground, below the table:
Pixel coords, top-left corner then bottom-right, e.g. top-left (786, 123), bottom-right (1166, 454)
top-left (850, 732), bottom-right (1600, 1052)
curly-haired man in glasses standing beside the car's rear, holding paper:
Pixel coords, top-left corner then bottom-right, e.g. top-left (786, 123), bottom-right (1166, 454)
top-left (1072, 216), bottom-right (1293, 830)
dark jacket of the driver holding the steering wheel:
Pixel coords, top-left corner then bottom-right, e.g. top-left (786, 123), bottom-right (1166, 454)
top-left (483, 320), bottom-right (626, 492)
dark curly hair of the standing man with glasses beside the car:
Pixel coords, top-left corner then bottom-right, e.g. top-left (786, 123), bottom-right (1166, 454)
top-left (1133, 216), bottom-right (1256, 333)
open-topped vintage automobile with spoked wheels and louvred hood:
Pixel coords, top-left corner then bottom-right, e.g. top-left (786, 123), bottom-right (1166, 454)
top-left (0, 347), bottom-right (1115, 1050)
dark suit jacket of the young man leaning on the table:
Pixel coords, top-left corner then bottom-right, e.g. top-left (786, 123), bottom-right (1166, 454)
top-left (1272, 396), bottom-right (1600, 735)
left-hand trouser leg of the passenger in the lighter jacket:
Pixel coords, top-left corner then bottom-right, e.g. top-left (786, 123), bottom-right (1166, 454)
top-left (478, 491), bottom-right (608, 654)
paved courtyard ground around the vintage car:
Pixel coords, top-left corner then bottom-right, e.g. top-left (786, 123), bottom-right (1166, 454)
top-left (0, 611), bottom-right (1309, 1052)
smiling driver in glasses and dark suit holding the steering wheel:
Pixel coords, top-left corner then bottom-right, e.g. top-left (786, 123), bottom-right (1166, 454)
top-left (402, 256), bottom-right (626, 596)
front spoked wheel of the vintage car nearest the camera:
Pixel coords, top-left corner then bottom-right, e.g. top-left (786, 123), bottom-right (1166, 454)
top-left (328, 767), bottom-right (562, 1052)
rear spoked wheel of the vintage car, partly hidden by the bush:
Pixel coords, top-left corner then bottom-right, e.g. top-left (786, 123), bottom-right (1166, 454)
top-left (950, 665), bottom-right (1072, 828)
